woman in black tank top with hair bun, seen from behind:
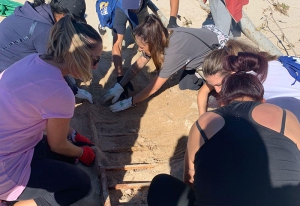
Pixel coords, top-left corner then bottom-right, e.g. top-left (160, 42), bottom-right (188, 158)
top-left (148, 53), bottom-right (300, 206)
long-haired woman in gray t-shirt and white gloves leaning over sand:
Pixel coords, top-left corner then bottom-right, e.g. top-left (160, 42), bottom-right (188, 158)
top-left (103, 14), bottom-right (228, 112)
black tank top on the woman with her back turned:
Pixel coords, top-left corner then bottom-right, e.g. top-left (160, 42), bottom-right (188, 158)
top-left (194, 102), bottom-right (300, 206)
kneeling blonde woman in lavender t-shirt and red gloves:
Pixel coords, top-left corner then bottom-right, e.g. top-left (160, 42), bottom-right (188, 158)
top-left (0, 15), bottom-right (103, 206)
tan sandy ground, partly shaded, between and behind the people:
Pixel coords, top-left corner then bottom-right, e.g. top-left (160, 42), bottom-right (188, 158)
top-left (0, 0), bottom-right (300, 205)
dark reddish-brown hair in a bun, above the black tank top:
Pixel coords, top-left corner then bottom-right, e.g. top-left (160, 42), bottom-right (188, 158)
top-left (219, 52), bottom-right (268, 105)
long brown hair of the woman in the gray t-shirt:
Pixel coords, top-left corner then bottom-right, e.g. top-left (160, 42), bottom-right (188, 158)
top-left (132, 14), bottom-right (169, 70)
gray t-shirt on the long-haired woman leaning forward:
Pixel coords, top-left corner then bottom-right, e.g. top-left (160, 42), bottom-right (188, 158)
top-left (159, 27), bottom-right (219, 78)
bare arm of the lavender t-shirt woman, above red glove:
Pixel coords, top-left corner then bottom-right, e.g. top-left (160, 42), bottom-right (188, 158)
top-left (47, 118), bottom-right (82, 157)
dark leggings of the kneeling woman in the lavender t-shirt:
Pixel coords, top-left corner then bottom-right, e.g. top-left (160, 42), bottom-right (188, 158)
top-left (17, 139), bottom-right (91, 206)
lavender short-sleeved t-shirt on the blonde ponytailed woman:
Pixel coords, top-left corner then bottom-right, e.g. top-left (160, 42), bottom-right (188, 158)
top-left (0, 54), bottom-right (75, 201)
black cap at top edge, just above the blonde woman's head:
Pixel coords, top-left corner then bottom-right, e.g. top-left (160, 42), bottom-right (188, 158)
top-left (59, 0), bottom-right (86, 22)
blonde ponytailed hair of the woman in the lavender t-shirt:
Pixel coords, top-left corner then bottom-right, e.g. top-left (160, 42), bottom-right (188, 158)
top-left (43, 15), bottom-right (102, 82)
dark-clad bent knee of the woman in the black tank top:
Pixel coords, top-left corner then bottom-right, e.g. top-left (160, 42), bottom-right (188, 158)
top-left (147, 174), bottom-right (196, 206)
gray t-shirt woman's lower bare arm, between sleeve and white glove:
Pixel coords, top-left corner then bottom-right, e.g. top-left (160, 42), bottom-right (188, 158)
top-left (132, 75), bottom-right (168, 104)
